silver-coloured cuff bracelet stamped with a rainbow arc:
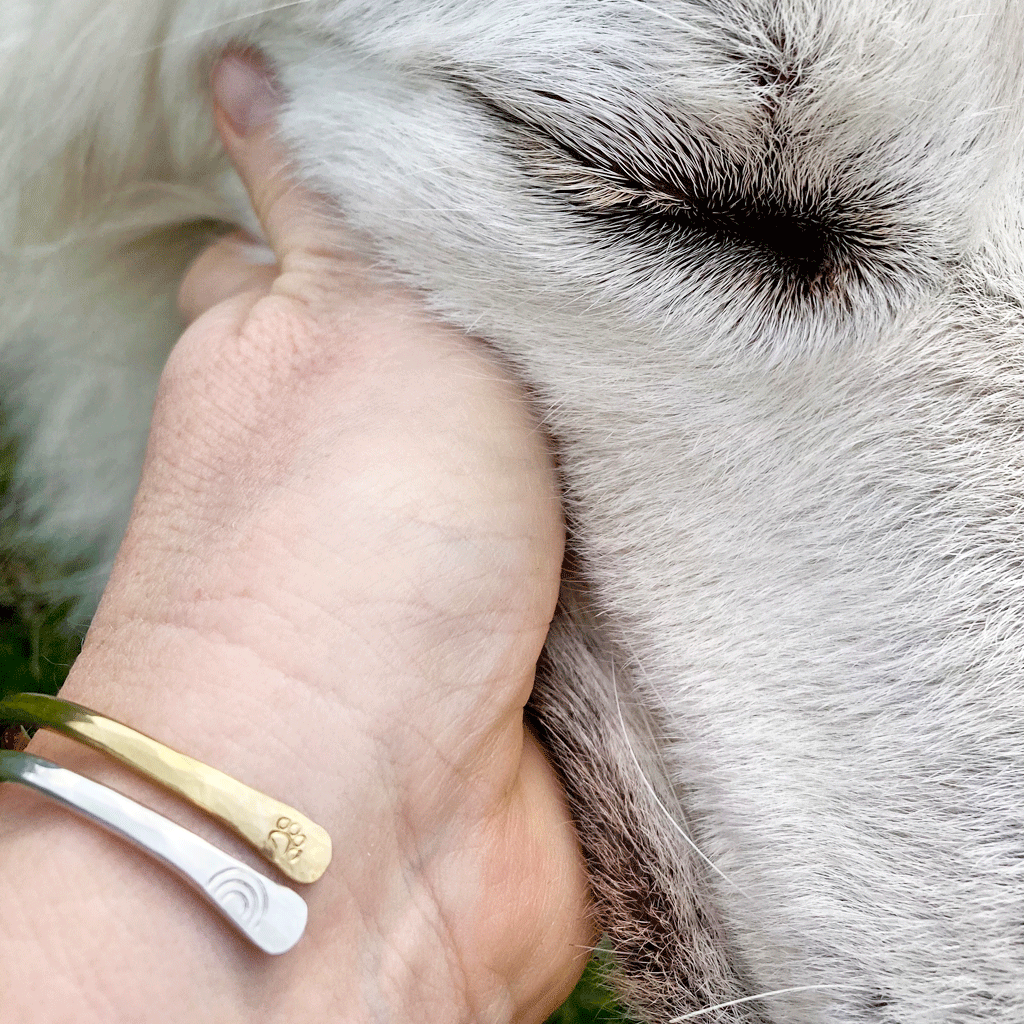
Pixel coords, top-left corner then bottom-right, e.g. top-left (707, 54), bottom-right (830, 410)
top-left (0, 751), bottom-right (307, 953)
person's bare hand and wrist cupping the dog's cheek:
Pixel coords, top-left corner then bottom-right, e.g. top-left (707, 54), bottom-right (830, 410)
top-left (0, 55), bottom-right (594, 1024)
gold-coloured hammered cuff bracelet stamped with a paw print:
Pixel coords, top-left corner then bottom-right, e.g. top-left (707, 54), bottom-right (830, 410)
top-left (0, 693), bottom-right (331, 882)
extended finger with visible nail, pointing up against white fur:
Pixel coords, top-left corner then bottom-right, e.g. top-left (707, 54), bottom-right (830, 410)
top-left (212, 50), bottom-right (331, 263)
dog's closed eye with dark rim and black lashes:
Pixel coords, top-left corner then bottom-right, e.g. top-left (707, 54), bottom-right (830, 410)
top-left (460, 81), bottom-right (937, 307)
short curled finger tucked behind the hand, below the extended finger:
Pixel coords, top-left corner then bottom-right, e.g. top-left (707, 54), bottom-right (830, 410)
top-left (178, 231), bottom-right (278, 324)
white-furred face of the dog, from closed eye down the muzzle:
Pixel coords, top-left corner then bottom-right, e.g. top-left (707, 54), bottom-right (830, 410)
top-left (262, 8), bottom-right (1024, 1024)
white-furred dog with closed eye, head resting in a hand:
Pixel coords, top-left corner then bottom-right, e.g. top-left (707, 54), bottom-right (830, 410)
top-left (0, 0), bottom-right (1024, 1024)
